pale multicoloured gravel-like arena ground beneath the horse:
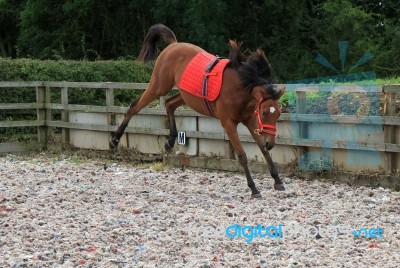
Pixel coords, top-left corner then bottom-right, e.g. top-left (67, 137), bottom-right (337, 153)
top-left (0, 155), bottom-right (400, 267)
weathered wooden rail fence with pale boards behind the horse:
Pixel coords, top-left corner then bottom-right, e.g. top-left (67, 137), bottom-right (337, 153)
top-left (0, 82), bottom-right (400, 175)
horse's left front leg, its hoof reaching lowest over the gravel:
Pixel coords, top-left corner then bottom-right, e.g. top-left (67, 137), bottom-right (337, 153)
top-left (221, 122), bottom-right (261, 198)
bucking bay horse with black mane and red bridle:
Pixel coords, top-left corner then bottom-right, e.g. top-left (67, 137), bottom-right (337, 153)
top-left (109, 24), bottom-right (285, 198)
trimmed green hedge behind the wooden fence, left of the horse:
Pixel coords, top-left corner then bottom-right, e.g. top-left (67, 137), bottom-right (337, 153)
top-left (0, 58), bottom-right (152, 106)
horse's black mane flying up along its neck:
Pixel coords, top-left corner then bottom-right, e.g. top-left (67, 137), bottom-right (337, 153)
top-left (229, 40), bottom-right (276, 96)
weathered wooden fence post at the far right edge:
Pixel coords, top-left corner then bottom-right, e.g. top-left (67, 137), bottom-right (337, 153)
top-left (383, 86), bottom-right (397, 172)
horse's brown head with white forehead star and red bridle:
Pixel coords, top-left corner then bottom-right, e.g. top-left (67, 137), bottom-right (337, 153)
top-left (252, 84), bottom-right (285, 151)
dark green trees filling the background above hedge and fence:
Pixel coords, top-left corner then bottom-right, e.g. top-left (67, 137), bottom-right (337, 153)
top-left (0, 0), bottom-right (400, 80)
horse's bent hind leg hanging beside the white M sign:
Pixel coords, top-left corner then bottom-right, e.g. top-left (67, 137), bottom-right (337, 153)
top-left (165, 93), bottom-right (185, 152)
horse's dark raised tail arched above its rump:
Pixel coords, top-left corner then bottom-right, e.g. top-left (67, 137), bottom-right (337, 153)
top-left (137, 24), bottom-right (177, 62)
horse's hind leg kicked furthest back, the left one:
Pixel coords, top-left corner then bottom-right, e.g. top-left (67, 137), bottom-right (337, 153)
top-left (109, 89), bottom-right (160, 149)
